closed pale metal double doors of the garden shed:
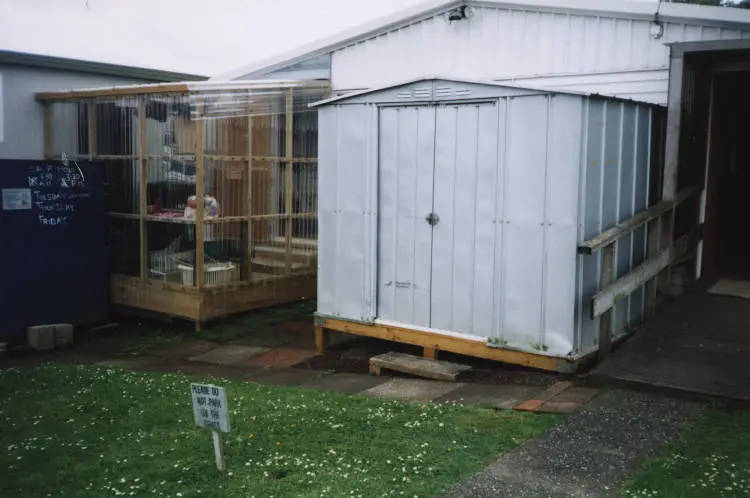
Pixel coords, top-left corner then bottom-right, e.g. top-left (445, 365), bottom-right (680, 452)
top-left (377, 102), bottom-right (499, 335)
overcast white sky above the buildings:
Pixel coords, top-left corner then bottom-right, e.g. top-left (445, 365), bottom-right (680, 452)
top-left (0, 0), bottom-right (423, 76)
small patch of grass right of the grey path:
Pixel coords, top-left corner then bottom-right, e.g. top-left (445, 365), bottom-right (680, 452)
top-left (623, 410), bottom-right (750, 498)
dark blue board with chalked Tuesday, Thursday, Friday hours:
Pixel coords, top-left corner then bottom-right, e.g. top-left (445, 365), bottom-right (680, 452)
top-left (0, 160), bottom-right (108, 340)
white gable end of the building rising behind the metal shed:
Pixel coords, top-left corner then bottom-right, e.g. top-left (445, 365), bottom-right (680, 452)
top-left (223, 0), bottom-right (750, 104)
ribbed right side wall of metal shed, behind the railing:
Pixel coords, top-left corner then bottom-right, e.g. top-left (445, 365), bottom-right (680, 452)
top-left (576, 97), bottom-right (653, 354)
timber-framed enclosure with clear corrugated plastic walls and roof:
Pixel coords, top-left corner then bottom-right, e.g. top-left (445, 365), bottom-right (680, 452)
top-left (37, 81), bottom-right (330, 327)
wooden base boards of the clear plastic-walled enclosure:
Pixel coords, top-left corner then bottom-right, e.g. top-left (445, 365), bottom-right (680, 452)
top-left (110, 275), bottom-right (316, 329)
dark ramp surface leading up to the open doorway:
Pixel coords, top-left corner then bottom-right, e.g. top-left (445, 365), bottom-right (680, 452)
top-left (591, 291), bottom-right (750, 402)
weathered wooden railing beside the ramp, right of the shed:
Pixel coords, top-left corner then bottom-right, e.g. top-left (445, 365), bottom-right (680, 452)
top-left (578, 187), bottom-right (701, 359)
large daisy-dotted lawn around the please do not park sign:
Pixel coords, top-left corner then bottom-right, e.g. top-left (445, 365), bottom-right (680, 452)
top-left (0, 365), bottom-right (556, 498)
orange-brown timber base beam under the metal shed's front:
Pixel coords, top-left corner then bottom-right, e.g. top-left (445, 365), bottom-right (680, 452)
top-left (315, 317), bottom-right (580, 373)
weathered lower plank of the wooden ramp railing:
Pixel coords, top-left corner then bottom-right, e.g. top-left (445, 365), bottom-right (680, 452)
top-left (591, 233), bottom-right (696, 318)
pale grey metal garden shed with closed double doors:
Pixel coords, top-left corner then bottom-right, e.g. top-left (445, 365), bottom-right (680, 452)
top-left (318, 79), bottom-right (663, 359)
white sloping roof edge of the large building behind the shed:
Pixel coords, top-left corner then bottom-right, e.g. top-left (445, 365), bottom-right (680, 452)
top-left (216, 0), bottom-right (750, 80)
